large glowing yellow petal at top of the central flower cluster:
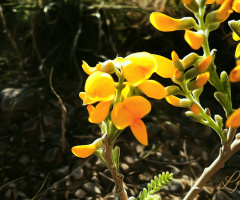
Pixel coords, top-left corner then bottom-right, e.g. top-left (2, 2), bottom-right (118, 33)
top-left (122, 52), bottom-right (157, 86)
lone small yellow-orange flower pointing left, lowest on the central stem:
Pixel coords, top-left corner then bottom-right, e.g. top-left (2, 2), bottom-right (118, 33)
top-left (72, 138), bottom-right (103, 158)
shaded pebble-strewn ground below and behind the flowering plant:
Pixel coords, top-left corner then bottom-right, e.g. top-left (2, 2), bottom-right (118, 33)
top-left (0, 74), bottom-right (240, 200)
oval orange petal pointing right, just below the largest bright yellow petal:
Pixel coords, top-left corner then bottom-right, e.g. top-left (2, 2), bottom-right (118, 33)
top-left (138, 80), bottom-right (168, 99)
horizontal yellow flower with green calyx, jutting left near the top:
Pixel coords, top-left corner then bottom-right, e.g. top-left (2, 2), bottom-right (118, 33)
top-left (150, 12), bottom-right (196, 32)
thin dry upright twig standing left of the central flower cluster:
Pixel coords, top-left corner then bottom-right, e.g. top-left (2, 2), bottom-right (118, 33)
top-left (49, 68), bottom-right (67, 152)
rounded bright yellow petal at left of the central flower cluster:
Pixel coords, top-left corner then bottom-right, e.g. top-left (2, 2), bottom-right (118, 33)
top-left (85, 72), bottom-right (116, 102)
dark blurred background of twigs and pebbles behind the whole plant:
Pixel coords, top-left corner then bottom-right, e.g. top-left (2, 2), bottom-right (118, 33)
top-left (0, 0), bottom-right (240, 200)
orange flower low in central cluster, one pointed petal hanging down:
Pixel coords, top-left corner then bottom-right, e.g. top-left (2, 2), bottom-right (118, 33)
top-left (111, 96), bottom-right (151, 145)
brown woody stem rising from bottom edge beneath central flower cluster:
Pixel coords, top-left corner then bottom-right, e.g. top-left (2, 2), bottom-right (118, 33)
top-left (102, 134), bottom-right (128, 200)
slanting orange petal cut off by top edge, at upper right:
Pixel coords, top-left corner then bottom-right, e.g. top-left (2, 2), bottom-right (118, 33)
top-left (215, 0), bottom-right (233, 22)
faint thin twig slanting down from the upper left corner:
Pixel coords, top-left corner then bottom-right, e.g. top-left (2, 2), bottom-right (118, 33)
top-left (0, 6), bottom-right (24, 69)
